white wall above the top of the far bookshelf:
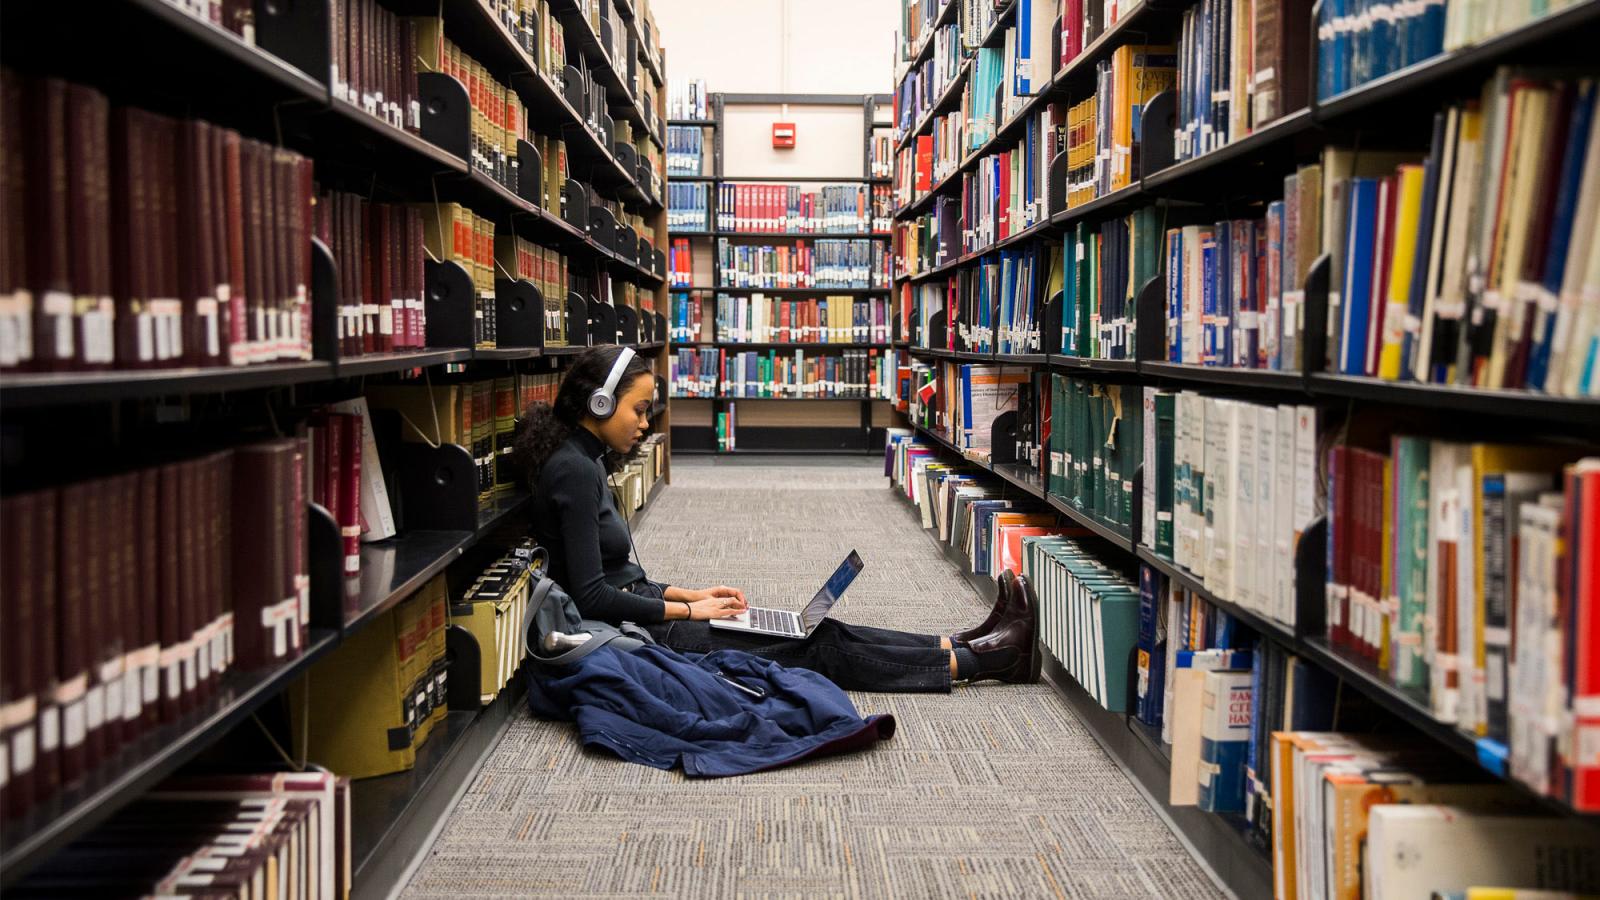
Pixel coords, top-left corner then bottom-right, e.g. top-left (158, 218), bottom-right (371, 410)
top-left (650, 0), bottom-right (899, 94)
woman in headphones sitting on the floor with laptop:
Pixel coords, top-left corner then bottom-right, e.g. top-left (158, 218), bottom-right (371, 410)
top-left (517, 344), bottom-right (1038, 692)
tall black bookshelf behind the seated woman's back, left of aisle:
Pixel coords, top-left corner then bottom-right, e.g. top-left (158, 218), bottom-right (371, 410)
top-left (0, 0), bottom-right (670, 897)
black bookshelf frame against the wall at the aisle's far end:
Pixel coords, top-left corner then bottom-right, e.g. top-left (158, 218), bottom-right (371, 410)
top-left (667, 93), bottom-right (893, 455)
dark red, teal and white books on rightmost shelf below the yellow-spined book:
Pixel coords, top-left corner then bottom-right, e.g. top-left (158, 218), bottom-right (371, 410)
top-left (1326, 434), bottom-right (1600, 794)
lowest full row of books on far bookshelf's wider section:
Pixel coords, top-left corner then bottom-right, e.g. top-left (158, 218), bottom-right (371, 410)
top-left (717, 349), bottom-right (896, 400)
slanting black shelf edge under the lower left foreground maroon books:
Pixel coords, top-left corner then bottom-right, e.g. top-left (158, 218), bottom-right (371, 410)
top-left (0, 629), bottom-right (339, 884)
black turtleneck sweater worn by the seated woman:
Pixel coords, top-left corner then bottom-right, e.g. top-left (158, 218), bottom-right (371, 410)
top-left (533, 428), bottom-right (662, 625)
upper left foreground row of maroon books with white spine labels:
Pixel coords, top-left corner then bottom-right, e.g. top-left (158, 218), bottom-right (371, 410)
top-left (0, 69), bottom-right (312, 370)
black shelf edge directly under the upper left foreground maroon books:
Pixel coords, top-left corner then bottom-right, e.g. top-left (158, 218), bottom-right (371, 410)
top-left (0, 360), bottom-right (333, 410)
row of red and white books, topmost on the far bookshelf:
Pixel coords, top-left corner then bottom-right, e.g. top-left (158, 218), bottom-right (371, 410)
top-left (717, 183), bottom-right (890, 234)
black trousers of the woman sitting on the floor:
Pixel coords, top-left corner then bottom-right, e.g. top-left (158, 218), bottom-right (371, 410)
top-left (627, 581), bottom-right (950, 693)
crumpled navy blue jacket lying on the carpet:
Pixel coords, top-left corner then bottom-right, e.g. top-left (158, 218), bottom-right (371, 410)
top-left (528, 644), bottom-right (894, 777)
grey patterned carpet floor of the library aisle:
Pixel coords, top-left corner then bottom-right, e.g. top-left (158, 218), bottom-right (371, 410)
top-left (396, 458), bottom-right (1222, 900)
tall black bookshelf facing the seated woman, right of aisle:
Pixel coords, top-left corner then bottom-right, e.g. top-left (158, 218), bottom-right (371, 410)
top-left (893, 2), bottom-right (1600, 897)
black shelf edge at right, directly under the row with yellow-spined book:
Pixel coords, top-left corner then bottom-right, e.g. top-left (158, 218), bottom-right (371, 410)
top-left (1307, 372), bottom-right (1600, 424)
